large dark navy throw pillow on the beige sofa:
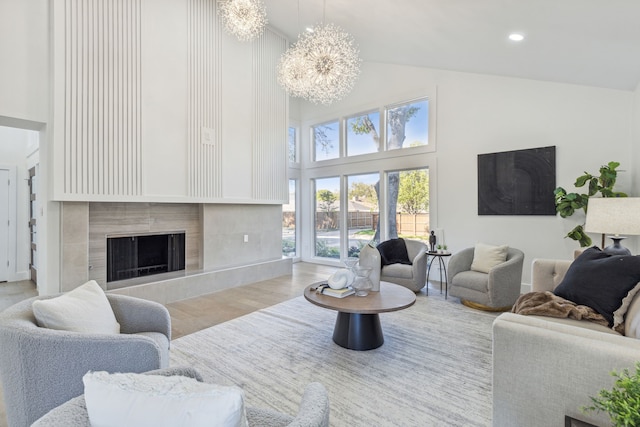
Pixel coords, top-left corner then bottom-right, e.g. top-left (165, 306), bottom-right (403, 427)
top-left (553, 246), bottom-right (640, 326)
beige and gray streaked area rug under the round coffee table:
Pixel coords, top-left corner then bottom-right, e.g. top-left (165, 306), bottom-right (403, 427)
top-left (171, 291), bottom-right (496, 427)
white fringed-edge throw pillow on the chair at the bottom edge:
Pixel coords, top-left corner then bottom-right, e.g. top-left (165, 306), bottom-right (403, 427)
top-left (82, 372), bottom-right (247, 427)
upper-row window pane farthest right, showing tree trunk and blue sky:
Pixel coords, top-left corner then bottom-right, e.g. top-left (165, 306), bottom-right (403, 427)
top-left (385, 99), bottom-right (429, 150)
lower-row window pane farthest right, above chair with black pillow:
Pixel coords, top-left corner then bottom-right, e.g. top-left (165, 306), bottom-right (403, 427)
top-left (387, 169), bottom-right (429, 239)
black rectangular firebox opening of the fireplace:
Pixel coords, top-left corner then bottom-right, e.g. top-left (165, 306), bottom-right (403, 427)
top-left (107, 232), bottom-right (185, 282)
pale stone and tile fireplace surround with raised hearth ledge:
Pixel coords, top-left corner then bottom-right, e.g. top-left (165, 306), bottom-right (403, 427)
top-left (60, 202), bottom-right (291, 304)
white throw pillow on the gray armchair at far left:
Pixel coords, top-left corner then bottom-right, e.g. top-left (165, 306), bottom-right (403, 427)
top-left (32, 280), bottom-right (120, 334)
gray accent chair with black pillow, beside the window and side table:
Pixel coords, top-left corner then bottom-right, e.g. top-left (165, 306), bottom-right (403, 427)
top-left (360, 239), bottom-right (427, 292)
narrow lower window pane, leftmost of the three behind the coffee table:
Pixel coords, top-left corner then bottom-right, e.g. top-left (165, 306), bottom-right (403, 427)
top-left (315, 177), bottom-right (341, 259)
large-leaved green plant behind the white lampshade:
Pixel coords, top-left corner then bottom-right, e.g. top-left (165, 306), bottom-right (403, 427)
top-left (553, 162), bottom-right (627, 247)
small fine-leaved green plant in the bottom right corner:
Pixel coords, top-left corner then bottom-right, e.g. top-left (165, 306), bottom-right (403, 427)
top-left (582, 362), bottom-right (640, 427)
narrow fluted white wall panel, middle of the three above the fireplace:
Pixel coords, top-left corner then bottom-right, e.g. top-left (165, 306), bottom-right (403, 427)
top-left (187, 0), bottom-right (222, 198)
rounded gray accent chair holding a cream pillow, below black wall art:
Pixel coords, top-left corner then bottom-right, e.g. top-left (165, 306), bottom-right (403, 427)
top-left (448, 248), bottom-right (524, 311)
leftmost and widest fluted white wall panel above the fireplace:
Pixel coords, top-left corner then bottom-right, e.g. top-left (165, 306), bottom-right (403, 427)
top-left (63, 0), bottom-right (142, 196)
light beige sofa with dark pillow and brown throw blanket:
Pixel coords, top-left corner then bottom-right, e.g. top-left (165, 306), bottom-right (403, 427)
top-left (493, 259), bottom-right (640, 427)
